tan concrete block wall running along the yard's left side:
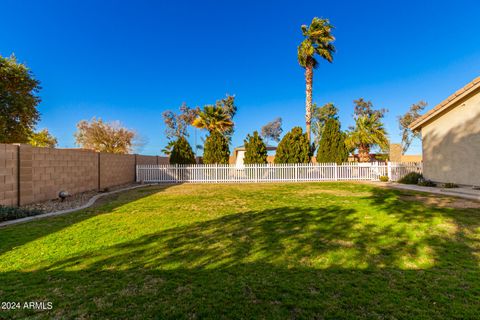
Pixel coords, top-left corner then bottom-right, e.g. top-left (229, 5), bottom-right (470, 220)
top-left (0, 144), bottom-right (168, 206)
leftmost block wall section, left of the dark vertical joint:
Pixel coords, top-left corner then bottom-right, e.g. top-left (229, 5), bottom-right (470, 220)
top-left (0, 144), bottom-right (18, 206)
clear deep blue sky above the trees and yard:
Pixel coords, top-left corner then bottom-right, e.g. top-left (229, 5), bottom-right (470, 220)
top-left (0, 0), bottom-right (480, 154)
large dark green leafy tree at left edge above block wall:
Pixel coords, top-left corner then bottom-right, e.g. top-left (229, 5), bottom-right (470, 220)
top-left (0, 55), bottom-right (41, 143)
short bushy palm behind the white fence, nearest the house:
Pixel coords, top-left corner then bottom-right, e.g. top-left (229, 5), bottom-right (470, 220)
top-left (345, 114), bottom-right (388, 162)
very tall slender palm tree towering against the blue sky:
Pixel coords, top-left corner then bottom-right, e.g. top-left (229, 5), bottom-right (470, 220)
top-left (298, 17), bottom-right (335, 141)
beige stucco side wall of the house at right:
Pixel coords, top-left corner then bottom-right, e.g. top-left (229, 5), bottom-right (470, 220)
top-left (422, 89), bottom-right (480, 185)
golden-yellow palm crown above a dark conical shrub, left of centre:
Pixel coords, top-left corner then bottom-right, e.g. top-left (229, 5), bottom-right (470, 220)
top-left (192, 105), bottom-right (233, 134)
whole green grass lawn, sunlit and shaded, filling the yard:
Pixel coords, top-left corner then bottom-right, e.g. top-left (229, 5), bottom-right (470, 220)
top-left (0, 183), bottom-right (480, 319)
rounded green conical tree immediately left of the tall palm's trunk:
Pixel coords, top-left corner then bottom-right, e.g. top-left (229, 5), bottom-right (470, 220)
top-left (275, 127), bottom-right (312, 163)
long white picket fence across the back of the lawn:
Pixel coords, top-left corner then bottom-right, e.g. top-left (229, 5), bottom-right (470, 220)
top-left (137, 162), bottom-right (422, 183)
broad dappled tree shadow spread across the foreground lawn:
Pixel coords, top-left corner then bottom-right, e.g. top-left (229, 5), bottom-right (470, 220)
top-left (0, 190), bottom-right (480, 319)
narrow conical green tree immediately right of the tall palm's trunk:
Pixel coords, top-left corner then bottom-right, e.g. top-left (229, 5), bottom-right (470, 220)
top-left (317, 118), bottom-right (348, 164)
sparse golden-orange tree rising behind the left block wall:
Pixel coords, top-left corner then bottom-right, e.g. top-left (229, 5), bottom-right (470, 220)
top-left (74, 118), bottom-right (138, 154)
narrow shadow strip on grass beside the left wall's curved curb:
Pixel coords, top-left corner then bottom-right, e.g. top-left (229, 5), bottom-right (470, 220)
top-left (0, 185), bottom-right (173, 255)
